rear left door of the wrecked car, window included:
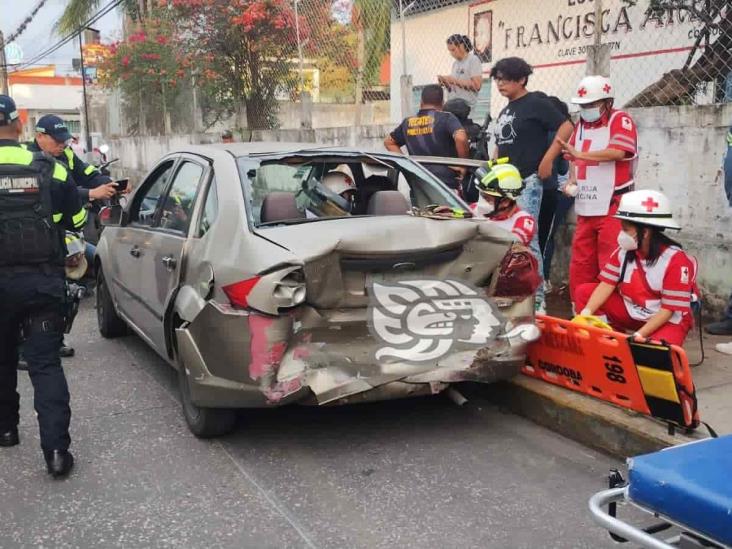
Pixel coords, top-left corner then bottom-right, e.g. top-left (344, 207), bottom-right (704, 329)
top-left (139, 155), bottom-right (209, 355)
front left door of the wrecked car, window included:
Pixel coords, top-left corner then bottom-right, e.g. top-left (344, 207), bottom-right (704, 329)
top-left (104, 157), bottom-right (178, 331)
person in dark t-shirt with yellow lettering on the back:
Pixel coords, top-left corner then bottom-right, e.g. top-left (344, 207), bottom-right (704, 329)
top-left (384, 84), bottom-right (470, 189)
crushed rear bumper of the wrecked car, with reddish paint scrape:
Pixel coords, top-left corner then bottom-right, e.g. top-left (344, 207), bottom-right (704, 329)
top-left (176, 299), bottom-right (539, 408)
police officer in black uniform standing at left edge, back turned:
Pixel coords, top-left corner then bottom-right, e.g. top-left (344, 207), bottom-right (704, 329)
top-left (0, 95), bottom-right (86, 478)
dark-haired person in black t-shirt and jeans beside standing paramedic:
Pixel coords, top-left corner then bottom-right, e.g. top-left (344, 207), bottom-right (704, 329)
top-left (491, 57), bottom-right (573, 312)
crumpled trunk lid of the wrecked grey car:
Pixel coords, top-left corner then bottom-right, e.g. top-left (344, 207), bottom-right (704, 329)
top-left (262, 215), bottom-right (512, 309)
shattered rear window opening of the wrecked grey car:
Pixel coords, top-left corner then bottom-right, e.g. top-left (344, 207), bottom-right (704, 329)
top-left (238, 153), bottom-right (466, 226)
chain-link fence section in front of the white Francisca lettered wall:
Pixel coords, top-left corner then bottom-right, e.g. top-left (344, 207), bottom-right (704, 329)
top-left (391, 0), bottom-right (732, 119)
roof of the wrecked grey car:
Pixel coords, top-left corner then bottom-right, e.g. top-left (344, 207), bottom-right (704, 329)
top-left (165, 141), bottom-right (404, 158)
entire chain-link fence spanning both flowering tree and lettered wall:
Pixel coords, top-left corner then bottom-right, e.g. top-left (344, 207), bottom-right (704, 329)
top-left (94, 0), bottom-right (732, 133)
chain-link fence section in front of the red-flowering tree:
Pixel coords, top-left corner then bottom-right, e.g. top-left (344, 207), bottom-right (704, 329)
top-left (93, 0), bottom-right (392, 134)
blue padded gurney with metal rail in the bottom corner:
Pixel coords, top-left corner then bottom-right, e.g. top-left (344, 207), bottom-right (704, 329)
top-left (590, 435), bottom-right (732, 549)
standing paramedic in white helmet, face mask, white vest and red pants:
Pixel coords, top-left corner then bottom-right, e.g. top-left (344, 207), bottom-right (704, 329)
top-left (560, 76), bottom-right (638, 310)
